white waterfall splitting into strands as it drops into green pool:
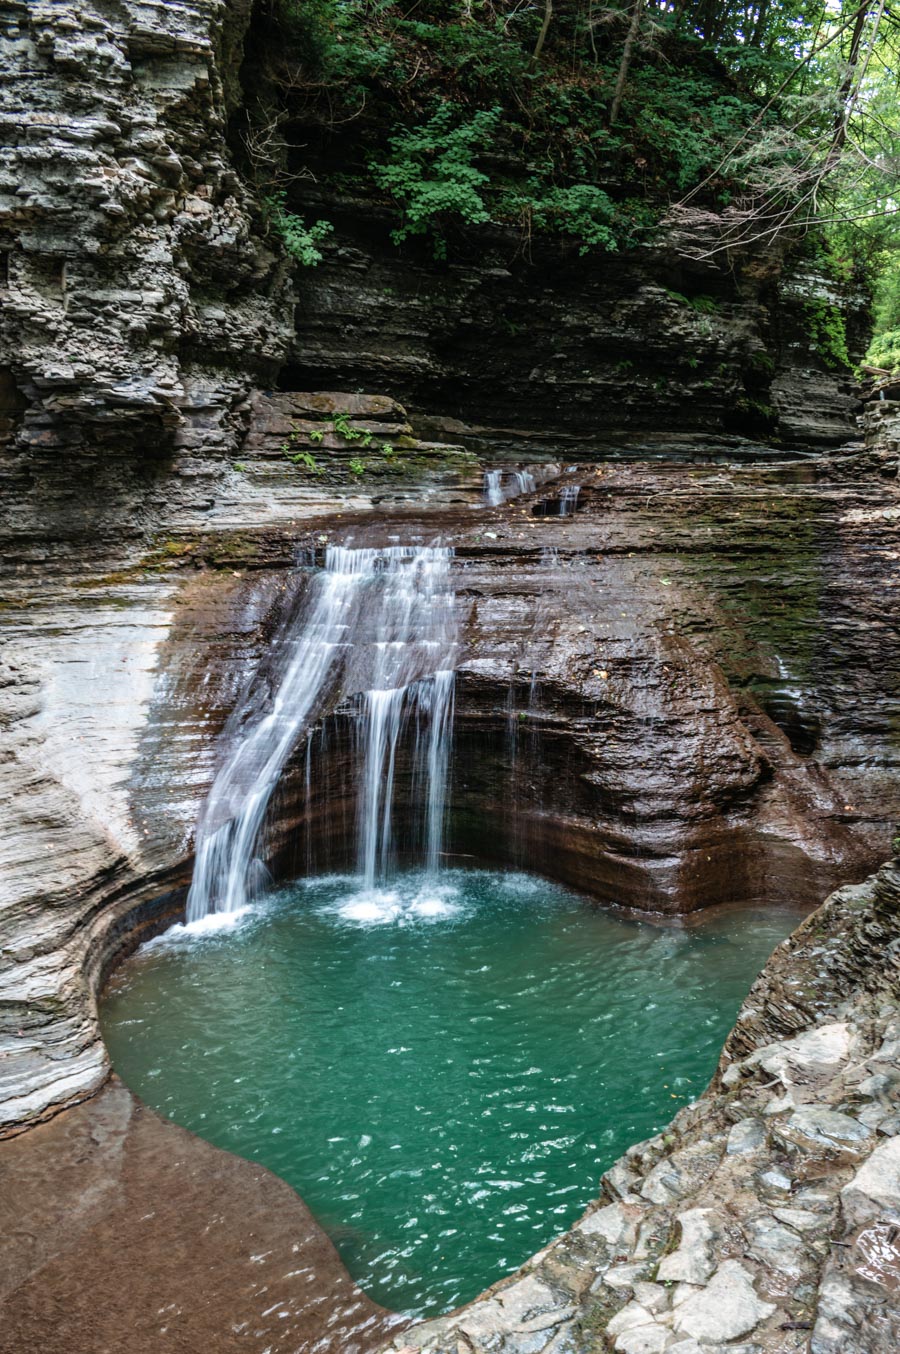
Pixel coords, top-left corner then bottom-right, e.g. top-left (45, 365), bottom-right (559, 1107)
top-left (187, 546), bottom-right (456, 921)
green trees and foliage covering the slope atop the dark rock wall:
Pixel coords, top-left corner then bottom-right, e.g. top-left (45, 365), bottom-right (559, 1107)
top-left (263, 0), bottom-right (900, 310)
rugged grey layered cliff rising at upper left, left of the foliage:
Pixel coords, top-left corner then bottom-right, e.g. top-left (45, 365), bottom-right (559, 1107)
top-left (0, 0), bottom-right (292, 565)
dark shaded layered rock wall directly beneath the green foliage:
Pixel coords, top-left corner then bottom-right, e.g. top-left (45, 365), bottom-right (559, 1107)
top-left (280, 192), bottom-right (865, 451)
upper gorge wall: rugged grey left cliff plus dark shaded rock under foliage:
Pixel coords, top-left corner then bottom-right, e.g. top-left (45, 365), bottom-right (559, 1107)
top-left (0, 0), bottom-right (862, 587)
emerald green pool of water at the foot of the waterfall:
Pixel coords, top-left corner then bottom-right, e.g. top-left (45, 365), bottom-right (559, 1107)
top-left (103, 871), bottom-right (796, 1315)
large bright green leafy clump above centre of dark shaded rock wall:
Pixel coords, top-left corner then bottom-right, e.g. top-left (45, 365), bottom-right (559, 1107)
top-left (372, 102), bottom-right (501, 257)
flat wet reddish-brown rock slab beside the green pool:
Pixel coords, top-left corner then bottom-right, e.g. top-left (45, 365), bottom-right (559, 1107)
top-left (0, 1079), bottom-right (403, 1354)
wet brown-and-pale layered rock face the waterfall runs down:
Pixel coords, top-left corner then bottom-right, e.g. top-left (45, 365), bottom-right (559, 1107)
top-left (7, 449), bottom-right (900, 1128)
